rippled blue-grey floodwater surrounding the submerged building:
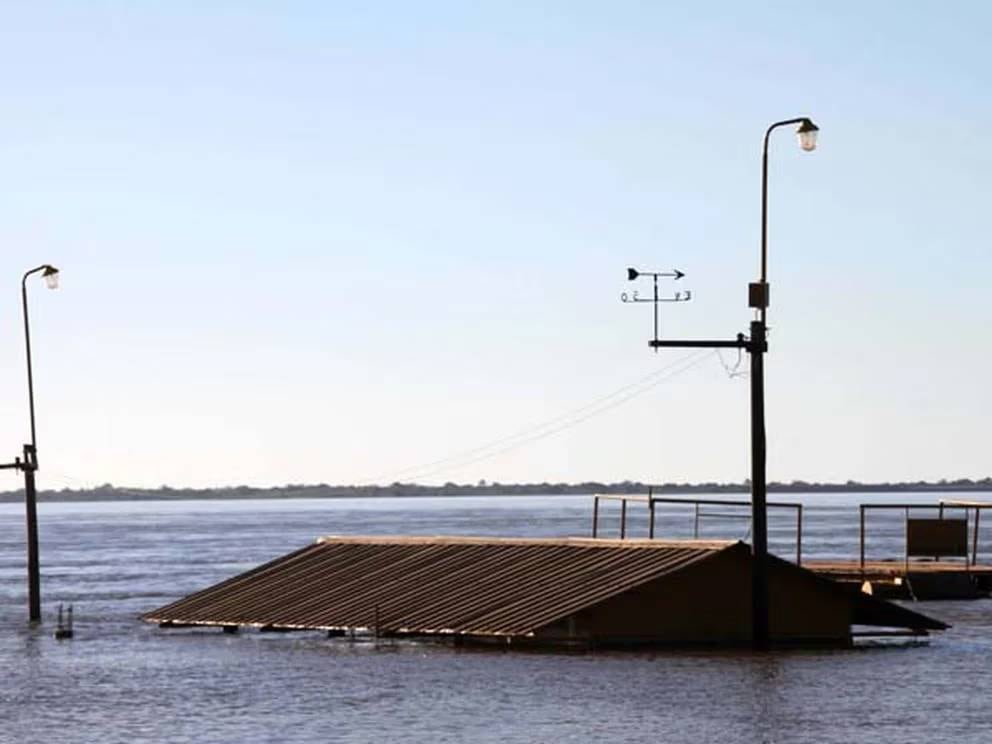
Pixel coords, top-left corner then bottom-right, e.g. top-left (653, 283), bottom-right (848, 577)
top-left (0, 494), bottom-right (992, 744)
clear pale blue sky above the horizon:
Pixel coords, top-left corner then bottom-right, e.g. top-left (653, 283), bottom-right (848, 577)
top-left (0, 0), bottom-right (992, 489)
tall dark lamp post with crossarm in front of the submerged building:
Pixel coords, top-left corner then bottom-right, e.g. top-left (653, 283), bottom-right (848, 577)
top-left (649, 117), bottom-right (820, 649)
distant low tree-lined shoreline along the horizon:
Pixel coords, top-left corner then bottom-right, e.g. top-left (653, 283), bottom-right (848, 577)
top-left (0, 478), bottom-right (992, 503)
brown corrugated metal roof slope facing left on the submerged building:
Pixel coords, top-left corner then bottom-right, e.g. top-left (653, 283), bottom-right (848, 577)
top-left (143, 537), bottom-right (739, 636)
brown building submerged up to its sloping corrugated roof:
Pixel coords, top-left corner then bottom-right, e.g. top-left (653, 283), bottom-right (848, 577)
top-left (142, 536), bottom-right (947, 646)
